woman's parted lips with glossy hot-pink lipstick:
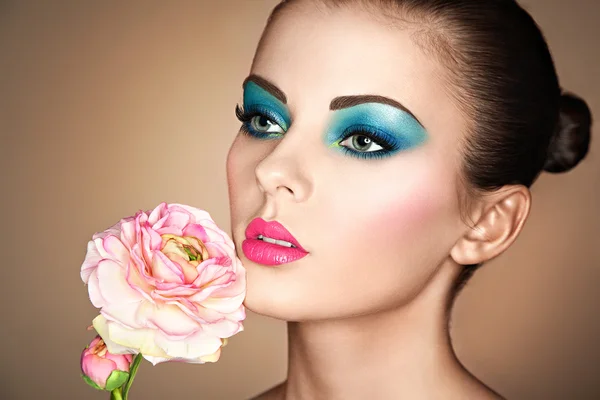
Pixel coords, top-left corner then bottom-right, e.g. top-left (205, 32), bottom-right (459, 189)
top-left (242, 218), bottom-right (308, 266)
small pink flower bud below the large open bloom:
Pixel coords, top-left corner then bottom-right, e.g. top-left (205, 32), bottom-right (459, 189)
top-left (81, 336), bottom-right (133, 390)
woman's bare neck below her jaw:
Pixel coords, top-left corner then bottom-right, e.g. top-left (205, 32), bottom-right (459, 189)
top-left (285, 260), bottom-right (464, 400)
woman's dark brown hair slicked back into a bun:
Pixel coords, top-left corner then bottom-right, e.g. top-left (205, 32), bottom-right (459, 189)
top-left (267, 0), bottom-right (592, 293)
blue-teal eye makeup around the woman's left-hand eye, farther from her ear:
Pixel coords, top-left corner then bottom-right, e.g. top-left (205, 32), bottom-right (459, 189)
top-left (236, 80), bottom-right (291, 139)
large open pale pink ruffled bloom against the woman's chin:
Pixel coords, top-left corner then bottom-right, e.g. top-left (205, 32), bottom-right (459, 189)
top-left (81, 203), bottom-right (246, 365)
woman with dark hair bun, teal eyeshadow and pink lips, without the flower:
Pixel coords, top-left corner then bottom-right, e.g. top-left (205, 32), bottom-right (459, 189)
top-left (227, 0), bottom-right (591, 400)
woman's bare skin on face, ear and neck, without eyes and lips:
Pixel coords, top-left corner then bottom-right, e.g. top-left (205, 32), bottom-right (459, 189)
top-left (227, 4), bottom-right (531, 400)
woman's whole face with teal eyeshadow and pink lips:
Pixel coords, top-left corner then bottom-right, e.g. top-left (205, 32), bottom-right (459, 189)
top-left (227, 6), bottom-right (465, 320)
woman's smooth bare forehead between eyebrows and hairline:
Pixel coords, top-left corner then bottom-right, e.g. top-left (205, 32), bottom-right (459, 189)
top-left (252, 3), bottom-right (453, 128)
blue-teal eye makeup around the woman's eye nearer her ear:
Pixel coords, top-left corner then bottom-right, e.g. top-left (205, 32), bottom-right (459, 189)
top-left (324, 103), bottom-right (428, 159)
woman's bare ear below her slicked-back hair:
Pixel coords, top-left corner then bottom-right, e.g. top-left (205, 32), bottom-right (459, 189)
top-left (450, 185), bottom-right (531, 265)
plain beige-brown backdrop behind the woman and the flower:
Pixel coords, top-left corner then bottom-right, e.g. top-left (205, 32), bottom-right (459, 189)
top-left (0, 0), bottom-right (600, 400)
